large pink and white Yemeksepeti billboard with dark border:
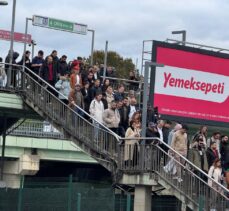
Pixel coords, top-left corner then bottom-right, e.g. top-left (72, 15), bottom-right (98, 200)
top-left (150, 41), bottom-right (229, 126)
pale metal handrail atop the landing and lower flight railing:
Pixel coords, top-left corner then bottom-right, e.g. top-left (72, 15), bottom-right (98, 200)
top-left (120, 137), bottom-right (229, 197)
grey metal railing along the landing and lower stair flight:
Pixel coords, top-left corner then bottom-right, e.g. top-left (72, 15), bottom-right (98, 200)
top-left (118, 138), bottom-right (229, 210)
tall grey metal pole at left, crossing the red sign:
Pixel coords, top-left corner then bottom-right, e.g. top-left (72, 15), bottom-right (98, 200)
top-left (7, 0), bottom-right (16, 87)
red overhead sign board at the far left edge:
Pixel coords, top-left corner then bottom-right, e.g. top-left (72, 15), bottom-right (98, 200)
top-left (0, 30), bottom-right (32, 44)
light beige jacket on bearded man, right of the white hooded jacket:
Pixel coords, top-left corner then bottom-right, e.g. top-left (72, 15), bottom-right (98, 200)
top-left (103, 108), bottom-right (120, 128)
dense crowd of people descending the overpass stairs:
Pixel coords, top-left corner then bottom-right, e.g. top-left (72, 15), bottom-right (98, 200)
top-left (0, 50), bottom-right (229, 193)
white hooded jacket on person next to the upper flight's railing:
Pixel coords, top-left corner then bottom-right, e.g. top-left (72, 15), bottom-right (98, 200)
top-left (89, 99), bottom-right (104, 124)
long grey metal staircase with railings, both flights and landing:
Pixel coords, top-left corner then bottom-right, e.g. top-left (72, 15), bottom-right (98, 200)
top-left (0, 63), bottom-right (229, 211)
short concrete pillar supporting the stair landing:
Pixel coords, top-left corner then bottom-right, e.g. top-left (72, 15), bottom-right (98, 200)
top-left (134, 185), bottom-right (152, 211)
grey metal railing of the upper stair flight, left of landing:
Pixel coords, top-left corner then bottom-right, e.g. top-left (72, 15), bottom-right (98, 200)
top-left (0, 64), bottom-right (119, 161)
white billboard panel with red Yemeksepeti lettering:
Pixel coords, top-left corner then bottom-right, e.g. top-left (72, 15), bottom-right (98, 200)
top-left (155, 66), bottom-right (229, 103)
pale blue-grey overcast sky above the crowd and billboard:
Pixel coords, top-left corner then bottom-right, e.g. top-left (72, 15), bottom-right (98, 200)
top-left (0, 0), bottom-right (229, 69)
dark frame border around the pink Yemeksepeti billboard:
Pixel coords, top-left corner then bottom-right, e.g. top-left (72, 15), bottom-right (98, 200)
top-left (149, 40), bottom-right (229, 127)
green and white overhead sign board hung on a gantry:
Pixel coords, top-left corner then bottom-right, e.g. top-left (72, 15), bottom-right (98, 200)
top-left (33, 15), bottom-right (87, 35)
